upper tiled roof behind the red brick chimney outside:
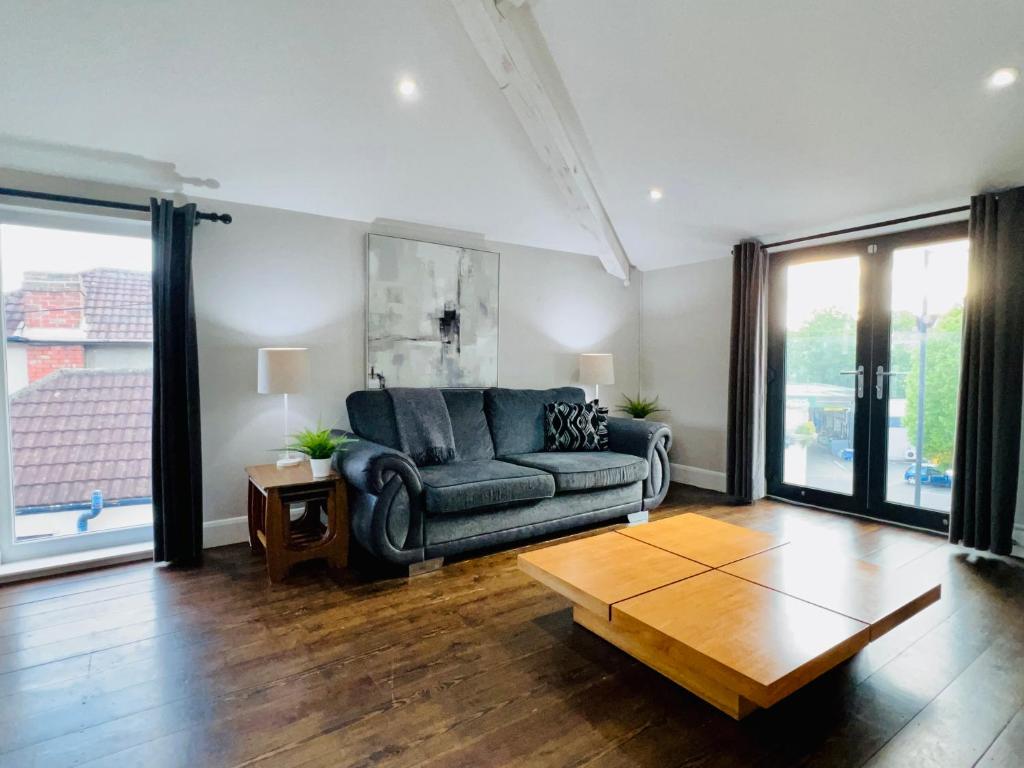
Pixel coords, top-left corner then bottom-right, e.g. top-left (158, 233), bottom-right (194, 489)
top-left (6, 268), bottom-right (153, 342)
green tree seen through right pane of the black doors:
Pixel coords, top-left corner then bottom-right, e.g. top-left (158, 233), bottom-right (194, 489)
top-left (903, 306), bottom-right (964, 470)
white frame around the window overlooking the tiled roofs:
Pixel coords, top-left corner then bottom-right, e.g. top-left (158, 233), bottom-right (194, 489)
top-left (0, 206), bottom-right (153, 564)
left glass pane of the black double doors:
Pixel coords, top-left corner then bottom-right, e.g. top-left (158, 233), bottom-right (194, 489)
top-left (782, 256), bottom-right (860, 495)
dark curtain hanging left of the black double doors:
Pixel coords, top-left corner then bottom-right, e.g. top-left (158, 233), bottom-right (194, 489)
top-left (726, 241), bottom-right (768, 504)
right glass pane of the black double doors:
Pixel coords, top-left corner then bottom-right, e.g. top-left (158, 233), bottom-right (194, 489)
top-left (886, 240), bottom-right (968, 512)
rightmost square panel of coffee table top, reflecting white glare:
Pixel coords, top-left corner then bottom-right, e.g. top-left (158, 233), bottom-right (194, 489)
top-left (722, 545), bottom-right (940, 640)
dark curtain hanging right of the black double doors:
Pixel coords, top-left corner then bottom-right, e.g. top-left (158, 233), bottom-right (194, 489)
top-left (949, 187), bottom-right (1024, 555)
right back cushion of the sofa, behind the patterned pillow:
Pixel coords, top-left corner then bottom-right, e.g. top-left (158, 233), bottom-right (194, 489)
top-left (483, 387), bottom-right (586, 457)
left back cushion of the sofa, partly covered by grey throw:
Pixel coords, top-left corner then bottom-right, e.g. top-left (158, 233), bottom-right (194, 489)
top-left (345, 389), bottom-right (495, 461)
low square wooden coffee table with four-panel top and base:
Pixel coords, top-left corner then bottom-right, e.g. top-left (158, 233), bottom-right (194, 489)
top-left (519, 514), bottom-right (940, 720)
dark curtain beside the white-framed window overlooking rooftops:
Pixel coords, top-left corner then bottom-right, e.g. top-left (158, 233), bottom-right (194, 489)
top-left (150, 199), bottom-right (203, 562)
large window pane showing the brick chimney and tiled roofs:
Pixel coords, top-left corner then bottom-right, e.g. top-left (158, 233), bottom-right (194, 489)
top-left (0, 224), bottom-right (153, 542)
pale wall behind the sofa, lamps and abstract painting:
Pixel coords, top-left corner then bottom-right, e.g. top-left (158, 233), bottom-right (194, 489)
top-left (193, 196), bottom-right (641, 538)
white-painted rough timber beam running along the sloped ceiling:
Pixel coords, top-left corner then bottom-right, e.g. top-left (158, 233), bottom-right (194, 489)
top-left (451, 0), bottom-right (630, 282)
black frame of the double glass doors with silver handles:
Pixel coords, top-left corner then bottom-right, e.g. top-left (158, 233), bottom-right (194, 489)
top-left (765, 221), bottom-right (968, 531)
